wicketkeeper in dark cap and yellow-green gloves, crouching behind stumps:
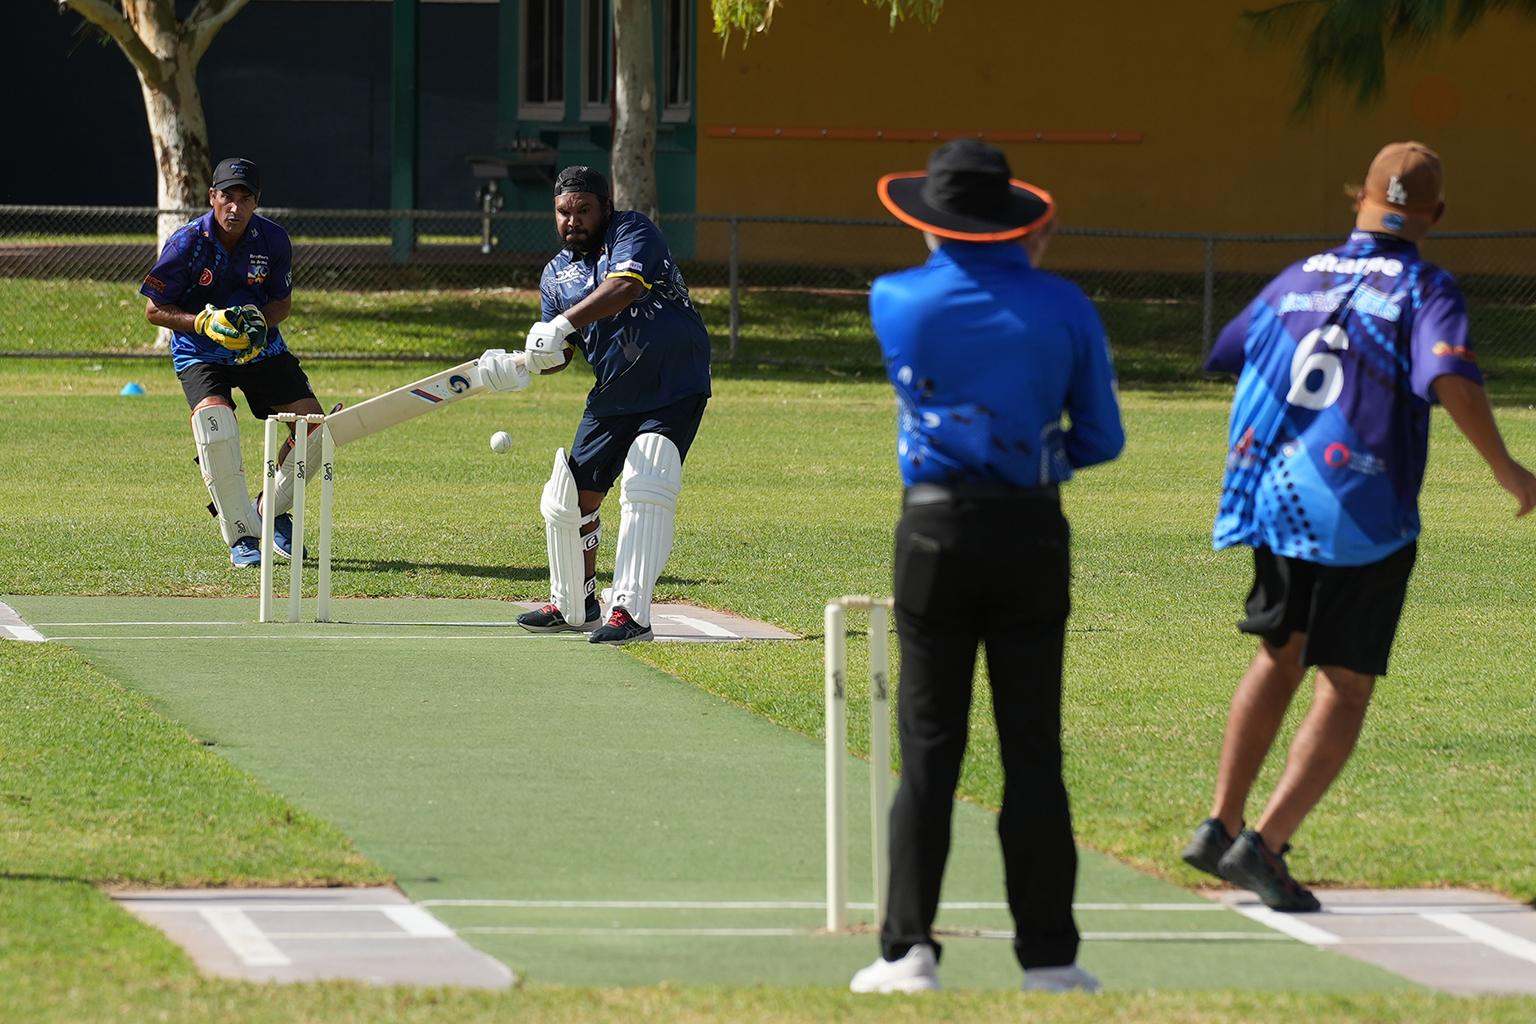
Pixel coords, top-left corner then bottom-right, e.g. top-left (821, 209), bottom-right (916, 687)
top-left (138, 157), bottom-right (323, 565)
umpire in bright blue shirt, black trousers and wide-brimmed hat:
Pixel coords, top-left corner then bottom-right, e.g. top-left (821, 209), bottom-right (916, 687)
top-left (849, 140), bottom-right (1124, 992)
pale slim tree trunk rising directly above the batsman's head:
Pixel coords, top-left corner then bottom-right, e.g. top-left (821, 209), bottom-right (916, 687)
top-left (613, 0), bottom-right (657, 221)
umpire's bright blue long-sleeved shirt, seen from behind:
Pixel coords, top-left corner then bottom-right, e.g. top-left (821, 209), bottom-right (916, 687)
top-left (869, 241), bottom-right (1126, 487)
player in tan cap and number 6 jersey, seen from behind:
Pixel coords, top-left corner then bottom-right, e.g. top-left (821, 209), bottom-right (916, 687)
top-left (1184, 143), bottom-right (1536, 910)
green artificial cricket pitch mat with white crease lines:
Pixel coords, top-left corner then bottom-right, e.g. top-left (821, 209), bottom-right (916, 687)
top-left (5, 597), bottom-right (1410, 992)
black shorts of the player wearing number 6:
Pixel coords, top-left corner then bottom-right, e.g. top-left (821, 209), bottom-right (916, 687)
top-left (1238, 540), bottom-right (1419, 676)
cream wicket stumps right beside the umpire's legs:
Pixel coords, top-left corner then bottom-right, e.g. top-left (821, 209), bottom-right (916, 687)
top-left (826, 594), bottom-right (892, 932)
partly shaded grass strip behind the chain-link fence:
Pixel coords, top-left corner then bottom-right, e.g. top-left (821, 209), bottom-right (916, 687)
top-left (0, 274), bottom-right (1536, 402)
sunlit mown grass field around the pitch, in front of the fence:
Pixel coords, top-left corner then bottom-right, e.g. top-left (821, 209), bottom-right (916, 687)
top-left (0, 348), bottom-right (1536, 1021)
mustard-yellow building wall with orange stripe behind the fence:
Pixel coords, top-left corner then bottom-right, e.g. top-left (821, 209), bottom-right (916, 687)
top-left (697, 0), bottom-right (1536, 264)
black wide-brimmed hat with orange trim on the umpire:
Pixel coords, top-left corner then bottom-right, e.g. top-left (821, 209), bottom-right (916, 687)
top-left (876, 138), bottom-right (1055, 241)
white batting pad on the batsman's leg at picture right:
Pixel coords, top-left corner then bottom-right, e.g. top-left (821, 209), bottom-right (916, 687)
top-left (613, 434), bottom-right (682, 626)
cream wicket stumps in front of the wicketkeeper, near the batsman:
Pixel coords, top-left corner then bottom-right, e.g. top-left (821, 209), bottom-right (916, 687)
top-left (261, 413), bottom-right (336, 622)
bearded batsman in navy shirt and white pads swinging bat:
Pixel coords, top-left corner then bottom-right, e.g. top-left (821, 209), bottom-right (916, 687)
top-left (479, 166), bottom-right (710, 646)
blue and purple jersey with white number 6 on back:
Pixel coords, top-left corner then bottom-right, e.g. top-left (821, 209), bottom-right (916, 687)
top-left (1206, 232), bottom-right (1482, 565)
